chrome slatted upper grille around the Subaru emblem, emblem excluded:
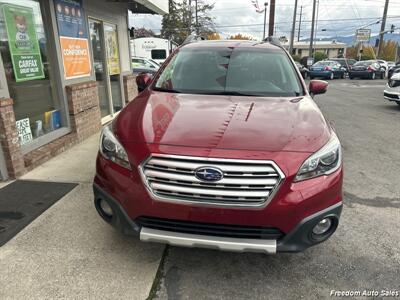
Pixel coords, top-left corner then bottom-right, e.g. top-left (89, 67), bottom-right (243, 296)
top-left (140, 155), bottom-right (284, 207)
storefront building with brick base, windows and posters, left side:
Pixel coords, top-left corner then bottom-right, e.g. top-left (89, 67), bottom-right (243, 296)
top-left (0, 0), bottom-right (168, 180)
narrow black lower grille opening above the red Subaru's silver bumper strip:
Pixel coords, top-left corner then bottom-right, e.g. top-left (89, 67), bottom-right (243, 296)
top-left (135, 216), bottom-right (284, 240)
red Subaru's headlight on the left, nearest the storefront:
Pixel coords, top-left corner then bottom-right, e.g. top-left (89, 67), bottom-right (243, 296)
top-left (100, 125), bottom-right (131, 170)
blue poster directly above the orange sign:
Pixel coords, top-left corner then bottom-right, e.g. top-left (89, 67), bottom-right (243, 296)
top-left (54, 0), bottom-right (88, 39)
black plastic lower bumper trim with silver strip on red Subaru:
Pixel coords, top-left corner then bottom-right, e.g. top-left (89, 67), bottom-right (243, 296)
top-left (93, 184), bottom-right (343, 254)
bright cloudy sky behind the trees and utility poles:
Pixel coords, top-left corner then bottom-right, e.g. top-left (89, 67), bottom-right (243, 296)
top-left (130, 0), bottom-right (400, 39)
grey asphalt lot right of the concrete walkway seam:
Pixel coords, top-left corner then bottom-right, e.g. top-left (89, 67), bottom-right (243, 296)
top-left (157, 80), bottom-right (400, 299)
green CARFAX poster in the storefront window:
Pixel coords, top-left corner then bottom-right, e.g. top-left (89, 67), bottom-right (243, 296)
top-left (3, 4), bottom-right (44, 82)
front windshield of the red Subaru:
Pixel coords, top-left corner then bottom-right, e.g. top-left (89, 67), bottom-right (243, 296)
top-left (154, 48), bottom-right (303, 97)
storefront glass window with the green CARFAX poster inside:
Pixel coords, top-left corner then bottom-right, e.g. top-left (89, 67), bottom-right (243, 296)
top-left (0, 0), bottom-right (63, 144)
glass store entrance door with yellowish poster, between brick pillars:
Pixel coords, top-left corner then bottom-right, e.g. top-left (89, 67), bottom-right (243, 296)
top-left (89, 19), bottom-right (123, 119)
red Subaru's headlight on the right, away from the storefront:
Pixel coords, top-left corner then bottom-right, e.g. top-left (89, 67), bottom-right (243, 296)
top-left (294, 133), bottom-right (342, 181)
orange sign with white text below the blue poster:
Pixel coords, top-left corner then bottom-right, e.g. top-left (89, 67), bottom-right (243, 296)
top-left (60, 37), bottom-right (91, 79)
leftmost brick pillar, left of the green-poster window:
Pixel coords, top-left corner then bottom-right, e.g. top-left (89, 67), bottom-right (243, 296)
top-left (0, 98), bottom-right (25, 178)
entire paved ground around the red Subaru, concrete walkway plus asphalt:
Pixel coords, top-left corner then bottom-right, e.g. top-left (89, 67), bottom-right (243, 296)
top-left (0, 80), bottom-right (400, 299)
